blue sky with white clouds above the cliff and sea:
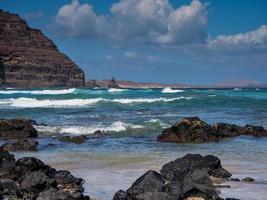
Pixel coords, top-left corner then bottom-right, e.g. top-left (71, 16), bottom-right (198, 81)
top-left (0, 0), bottom-right (267, 84)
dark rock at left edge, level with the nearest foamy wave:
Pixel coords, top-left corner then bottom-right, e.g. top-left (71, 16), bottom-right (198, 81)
top-left (0, 119), bottom-right (38, 139)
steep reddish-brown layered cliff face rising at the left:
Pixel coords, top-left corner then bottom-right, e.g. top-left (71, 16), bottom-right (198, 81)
top-left (0, 10), bottom-right (84, 87)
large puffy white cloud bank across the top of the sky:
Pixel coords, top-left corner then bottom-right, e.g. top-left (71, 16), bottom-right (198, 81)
top-left (55, 0), bottom-right (207, 44)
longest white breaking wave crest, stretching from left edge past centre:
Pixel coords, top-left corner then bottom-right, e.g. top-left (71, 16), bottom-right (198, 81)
top-left (0, 96), bottom-right (193, 108)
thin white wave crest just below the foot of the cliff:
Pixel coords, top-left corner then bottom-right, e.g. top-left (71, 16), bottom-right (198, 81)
top-left (0, 88), bottom-right (75, 95)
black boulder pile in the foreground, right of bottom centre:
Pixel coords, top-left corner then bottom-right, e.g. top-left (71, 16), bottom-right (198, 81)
top-left (113, 154), bottom-right (231, 200)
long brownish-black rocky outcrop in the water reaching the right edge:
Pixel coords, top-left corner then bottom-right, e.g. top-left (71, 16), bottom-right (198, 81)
top-left (157, 117), bottom-right (267, 143)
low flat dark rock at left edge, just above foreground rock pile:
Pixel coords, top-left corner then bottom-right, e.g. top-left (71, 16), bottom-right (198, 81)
top-left (2, 139), bottom-right (39, 151)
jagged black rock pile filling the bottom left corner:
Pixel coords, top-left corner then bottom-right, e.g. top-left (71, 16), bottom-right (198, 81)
top-left (0, 147), bottom-right (90, 200)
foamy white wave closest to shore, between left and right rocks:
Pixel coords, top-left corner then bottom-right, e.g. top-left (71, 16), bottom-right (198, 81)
top-left (35, 121), bottom-right (144, 135)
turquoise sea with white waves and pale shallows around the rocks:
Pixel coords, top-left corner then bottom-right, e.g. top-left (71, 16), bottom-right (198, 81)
top-left (0, 88), bottom-right (267, 200)
